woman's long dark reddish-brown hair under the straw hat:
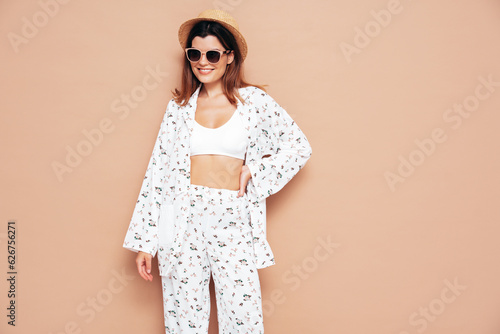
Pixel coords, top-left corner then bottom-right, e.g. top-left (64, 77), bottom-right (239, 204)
top-left (172, 21), bottom-right (265, 106)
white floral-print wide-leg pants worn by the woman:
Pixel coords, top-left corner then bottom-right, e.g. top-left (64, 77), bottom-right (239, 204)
top-left (162, 184), bottom-right (264, 334)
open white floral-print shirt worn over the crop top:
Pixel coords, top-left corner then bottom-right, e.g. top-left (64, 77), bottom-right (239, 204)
top-left (123, 85), bottom-right (312, 276)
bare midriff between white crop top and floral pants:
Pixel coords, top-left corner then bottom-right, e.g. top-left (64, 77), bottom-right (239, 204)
top-left (191, 154), bottom-right (244, 190)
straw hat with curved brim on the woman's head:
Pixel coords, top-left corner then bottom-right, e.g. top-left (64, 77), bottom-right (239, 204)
top-left (179, 9), bottom-right (248, 60)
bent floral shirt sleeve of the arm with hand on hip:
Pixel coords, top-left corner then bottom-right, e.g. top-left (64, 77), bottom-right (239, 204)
top-left (247, 91), bottom-right (312, 199)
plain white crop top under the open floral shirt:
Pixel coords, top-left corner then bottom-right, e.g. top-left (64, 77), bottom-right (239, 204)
top-left (191, 108), bottom-right (248, 160)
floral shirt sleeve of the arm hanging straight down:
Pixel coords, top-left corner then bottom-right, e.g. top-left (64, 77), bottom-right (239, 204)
top-left (123, 101), bottom-right (172, 256)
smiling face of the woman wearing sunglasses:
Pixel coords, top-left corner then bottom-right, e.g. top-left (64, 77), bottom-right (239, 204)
top-left (191, 35), bottom-right (234, 84)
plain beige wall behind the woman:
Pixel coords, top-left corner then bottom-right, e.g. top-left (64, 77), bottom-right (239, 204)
top-left (0, 0), bottom-right (500, 334)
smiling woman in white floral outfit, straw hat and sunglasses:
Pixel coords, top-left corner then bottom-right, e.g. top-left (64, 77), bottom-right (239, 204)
top-left (123, 10), bottom-right (312, 334)
